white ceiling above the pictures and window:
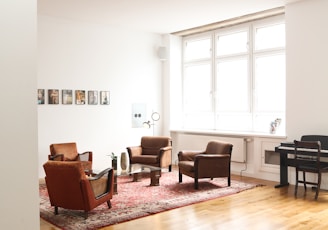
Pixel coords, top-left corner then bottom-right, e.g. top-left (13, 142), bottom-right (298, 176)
top-left (38, 0), bottom-right (298, 34)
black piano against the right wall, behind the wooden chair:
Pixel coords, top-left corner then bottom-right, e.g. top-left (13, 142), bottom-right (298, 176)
top-left (275, 135), bottom-right (328, 188)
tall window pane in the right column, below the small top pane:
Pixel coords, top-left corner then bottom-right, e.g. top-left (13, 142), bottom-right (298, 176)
top-left (255, 54), bottom-right (286, 112)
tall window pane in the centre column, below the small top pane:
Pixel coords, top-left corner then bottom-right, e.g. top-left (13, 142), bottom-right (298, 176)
top-left (216, 58), bottom-right (249, 112)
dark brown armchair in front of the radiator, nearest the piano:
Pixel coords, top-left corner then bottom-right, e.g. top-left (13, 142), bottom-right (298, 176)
top-left (178, 141), bottom-right (232, 189)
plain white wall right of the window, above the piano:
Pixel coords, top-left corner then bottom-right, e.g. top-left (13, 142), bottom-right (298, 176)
top-left (285, 0), bottom-right (328, 140)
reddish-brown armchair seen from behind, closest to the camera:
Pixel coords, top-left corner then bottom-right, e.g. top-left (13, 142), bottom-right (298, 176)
top-left (43, 161), bottom-right (114, 218)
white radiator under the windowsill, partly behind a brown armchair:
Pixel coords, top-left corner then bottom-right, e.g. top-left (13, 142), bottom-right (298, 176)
top-left (173, 133), bottom-right (246, 163)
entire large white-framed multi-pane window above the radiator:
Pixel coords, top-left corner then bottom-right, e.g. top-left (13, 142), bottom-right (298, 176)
top-left (183, 18), bottom-right (285, 132)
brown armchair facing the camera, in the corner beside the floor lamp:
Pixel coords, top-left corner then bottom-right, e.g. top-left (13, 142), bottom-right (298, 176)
top-left (126, 136), bottom-right (172, 172)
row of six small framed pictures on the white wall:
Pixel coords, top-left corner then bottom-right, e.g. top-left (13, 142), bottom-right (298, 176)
top-left (37, 89), bottom-right (109, 105)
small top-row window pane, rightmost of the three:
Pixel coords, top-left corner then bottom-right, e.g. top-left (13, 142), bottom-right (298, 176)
top-left (255, 24), bottom-right (285, 50)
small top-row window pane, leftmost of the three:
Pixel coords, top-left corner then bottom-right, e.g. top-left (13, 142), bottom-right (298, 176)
top-left (185, 38), bottom-right (211, 61)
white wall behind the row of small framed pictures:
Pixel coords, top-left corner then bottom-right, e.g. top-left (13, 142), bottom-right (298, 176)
top-left (38, 15), bottom-right (165, 177)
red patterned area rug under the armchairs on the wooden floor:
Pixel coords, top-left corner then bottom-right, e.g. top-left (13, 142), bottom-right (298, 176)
top-left (39, 171), bottom-right (257, 230)
